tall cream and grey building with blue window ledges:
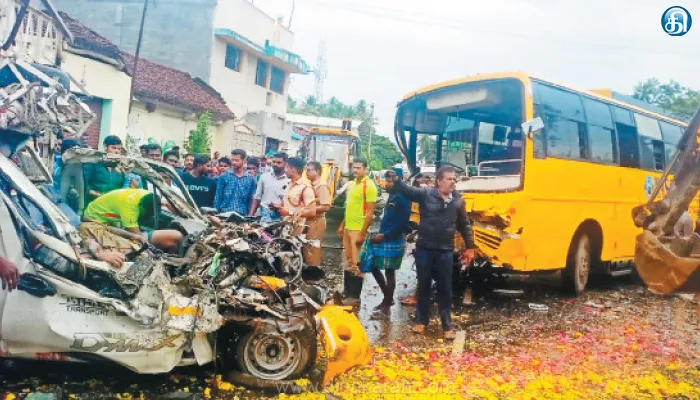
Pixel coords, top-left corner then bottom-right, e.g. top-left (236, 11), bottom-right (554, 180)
top-left (53, 0), bottom-right (312, 155)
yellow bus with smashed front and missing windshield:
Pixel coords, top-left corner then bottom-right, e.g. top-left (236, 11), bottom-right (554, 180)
top-left (395, 73), bottom-right (698, 294)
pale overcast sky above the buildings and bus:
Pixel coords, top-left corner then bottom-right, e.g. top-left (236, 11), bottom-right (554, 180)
top-left (254, 0), bottom-right (700, 136)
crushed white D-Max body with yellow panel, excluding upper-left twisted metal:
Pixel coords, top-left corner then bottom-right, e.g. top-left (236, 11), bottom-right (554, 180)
top-left (0, 149), bottom-right (372, 383)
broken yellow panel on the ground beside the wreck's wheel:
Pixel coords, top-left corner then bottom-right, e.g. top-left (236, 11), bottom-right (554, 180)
top-left (316, 305), bottom-right (374, 386)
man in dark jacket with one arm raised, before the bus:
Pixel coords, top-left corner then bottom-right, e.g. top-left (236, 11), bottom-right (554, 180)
top-left (392, 166), bottom-right (476, 340)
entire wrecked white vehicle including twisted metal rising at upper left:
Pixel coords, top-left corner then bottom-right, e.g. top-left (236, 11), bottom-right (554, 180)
top-left (0, 0), bottom-right (371, 390)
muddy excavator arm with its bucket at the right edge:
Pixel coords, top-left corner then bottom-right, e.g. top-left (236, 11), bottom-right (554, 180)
top-left (632, 108), bottom-right (700, 294)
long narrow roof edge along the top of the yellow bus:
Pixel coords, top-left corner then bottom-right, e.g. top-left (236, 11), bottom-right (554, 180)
top-left (400, 72), bottom-right (688, 125)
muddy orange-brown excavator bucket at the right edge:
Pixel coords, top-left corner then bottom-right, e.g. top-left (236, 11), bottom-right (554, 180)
top-left (634, 230), bottom-right (700, 294)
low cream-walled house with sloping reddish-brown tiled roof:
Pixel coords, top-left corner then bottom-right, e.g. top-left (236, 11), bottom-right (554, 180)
top-left (56, 12), bottom-right (235, 152)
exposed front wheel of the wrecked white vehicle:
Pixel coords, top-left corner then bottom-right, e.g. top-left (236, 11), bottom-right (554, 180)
top-left (221, 324), bottom-right (317, 381)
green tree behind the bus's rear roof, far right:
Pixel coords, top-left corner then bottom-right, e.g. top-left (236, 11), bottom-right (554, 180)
top-left (632, 78), bottom-right (700, 119)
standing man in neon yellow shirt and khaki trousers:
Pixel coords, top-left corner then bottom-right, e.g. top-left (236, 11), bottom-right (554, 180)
top-left (338, 159), bottom-right (378, 304)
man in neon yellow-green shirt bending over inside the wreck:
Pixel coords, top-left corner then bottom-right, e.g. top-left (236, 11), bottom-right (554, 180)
top-left (84, 189), bottom-right (183, 251)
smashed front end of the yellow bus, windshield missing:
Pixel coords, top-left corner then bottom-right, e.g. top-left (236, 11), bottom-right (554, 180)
top-left (395, 75), bottom-right (532, 278)
